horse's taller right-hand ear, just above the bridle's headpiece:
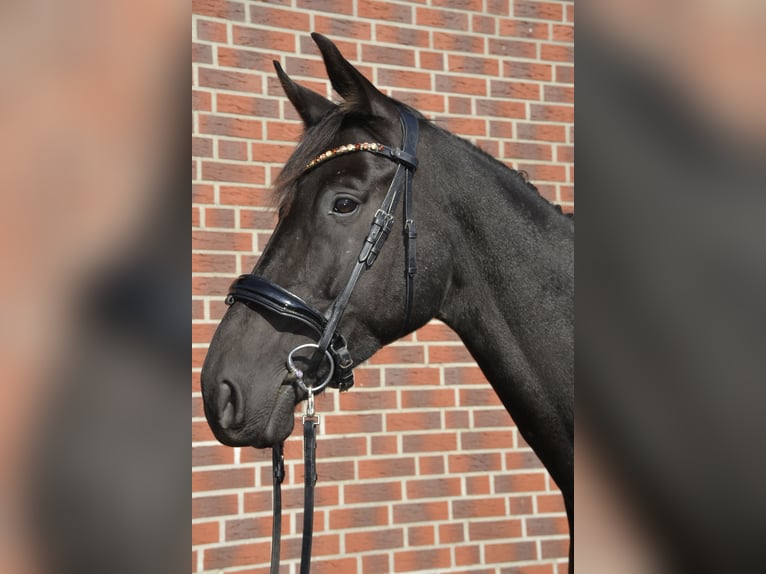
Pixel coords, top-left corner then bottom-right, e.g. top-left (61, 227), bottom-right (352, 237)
top-left (311, 32), bottom-right (398, 117)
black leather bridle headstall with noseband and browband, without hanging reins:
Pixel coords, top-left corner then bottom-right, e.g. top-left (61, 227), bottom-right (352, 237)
top-left (226, 109), bottom-right (418, 392)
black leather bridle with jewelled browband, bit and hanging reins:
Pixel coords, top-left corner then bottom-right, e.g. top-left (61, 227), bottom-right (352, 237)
top-left (226, 108), bottom-right (419, 574)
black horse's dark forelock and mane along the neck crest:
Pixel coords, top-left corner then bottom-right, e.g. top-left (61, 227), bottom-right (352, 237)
top-left (274, 100), bottom-right (573, 223)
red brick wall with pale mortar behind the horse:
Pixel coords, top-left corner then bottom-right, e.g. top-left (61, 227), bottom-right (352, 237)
top-left (192, 0), bottom-right (574, 574)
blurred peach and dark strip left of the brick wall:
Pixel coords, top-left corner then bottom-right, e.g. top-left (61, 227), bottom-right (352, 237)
top-left (0, 0), bottom-right (190, 574)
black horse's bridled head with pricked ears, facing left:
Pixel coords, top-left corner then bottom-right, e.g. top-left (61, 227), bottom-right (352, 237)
top-left (201, 34), bottom-right (449, 448)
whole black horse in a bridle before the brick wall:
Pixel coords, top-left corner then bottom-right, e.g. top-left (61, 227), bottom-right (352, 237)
top-left (202, 34), bottom-right (574, 571)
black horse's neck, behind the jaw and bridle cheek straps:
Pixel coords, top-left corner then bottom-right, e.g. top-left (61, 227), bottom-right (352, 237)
top-left (426, 130), bottom-right (574, 482)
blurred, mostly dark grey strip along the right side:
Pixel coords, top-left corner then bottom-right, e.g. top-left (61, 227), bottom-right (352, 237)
top-left (575, 0), bottom-right (766, 573)
